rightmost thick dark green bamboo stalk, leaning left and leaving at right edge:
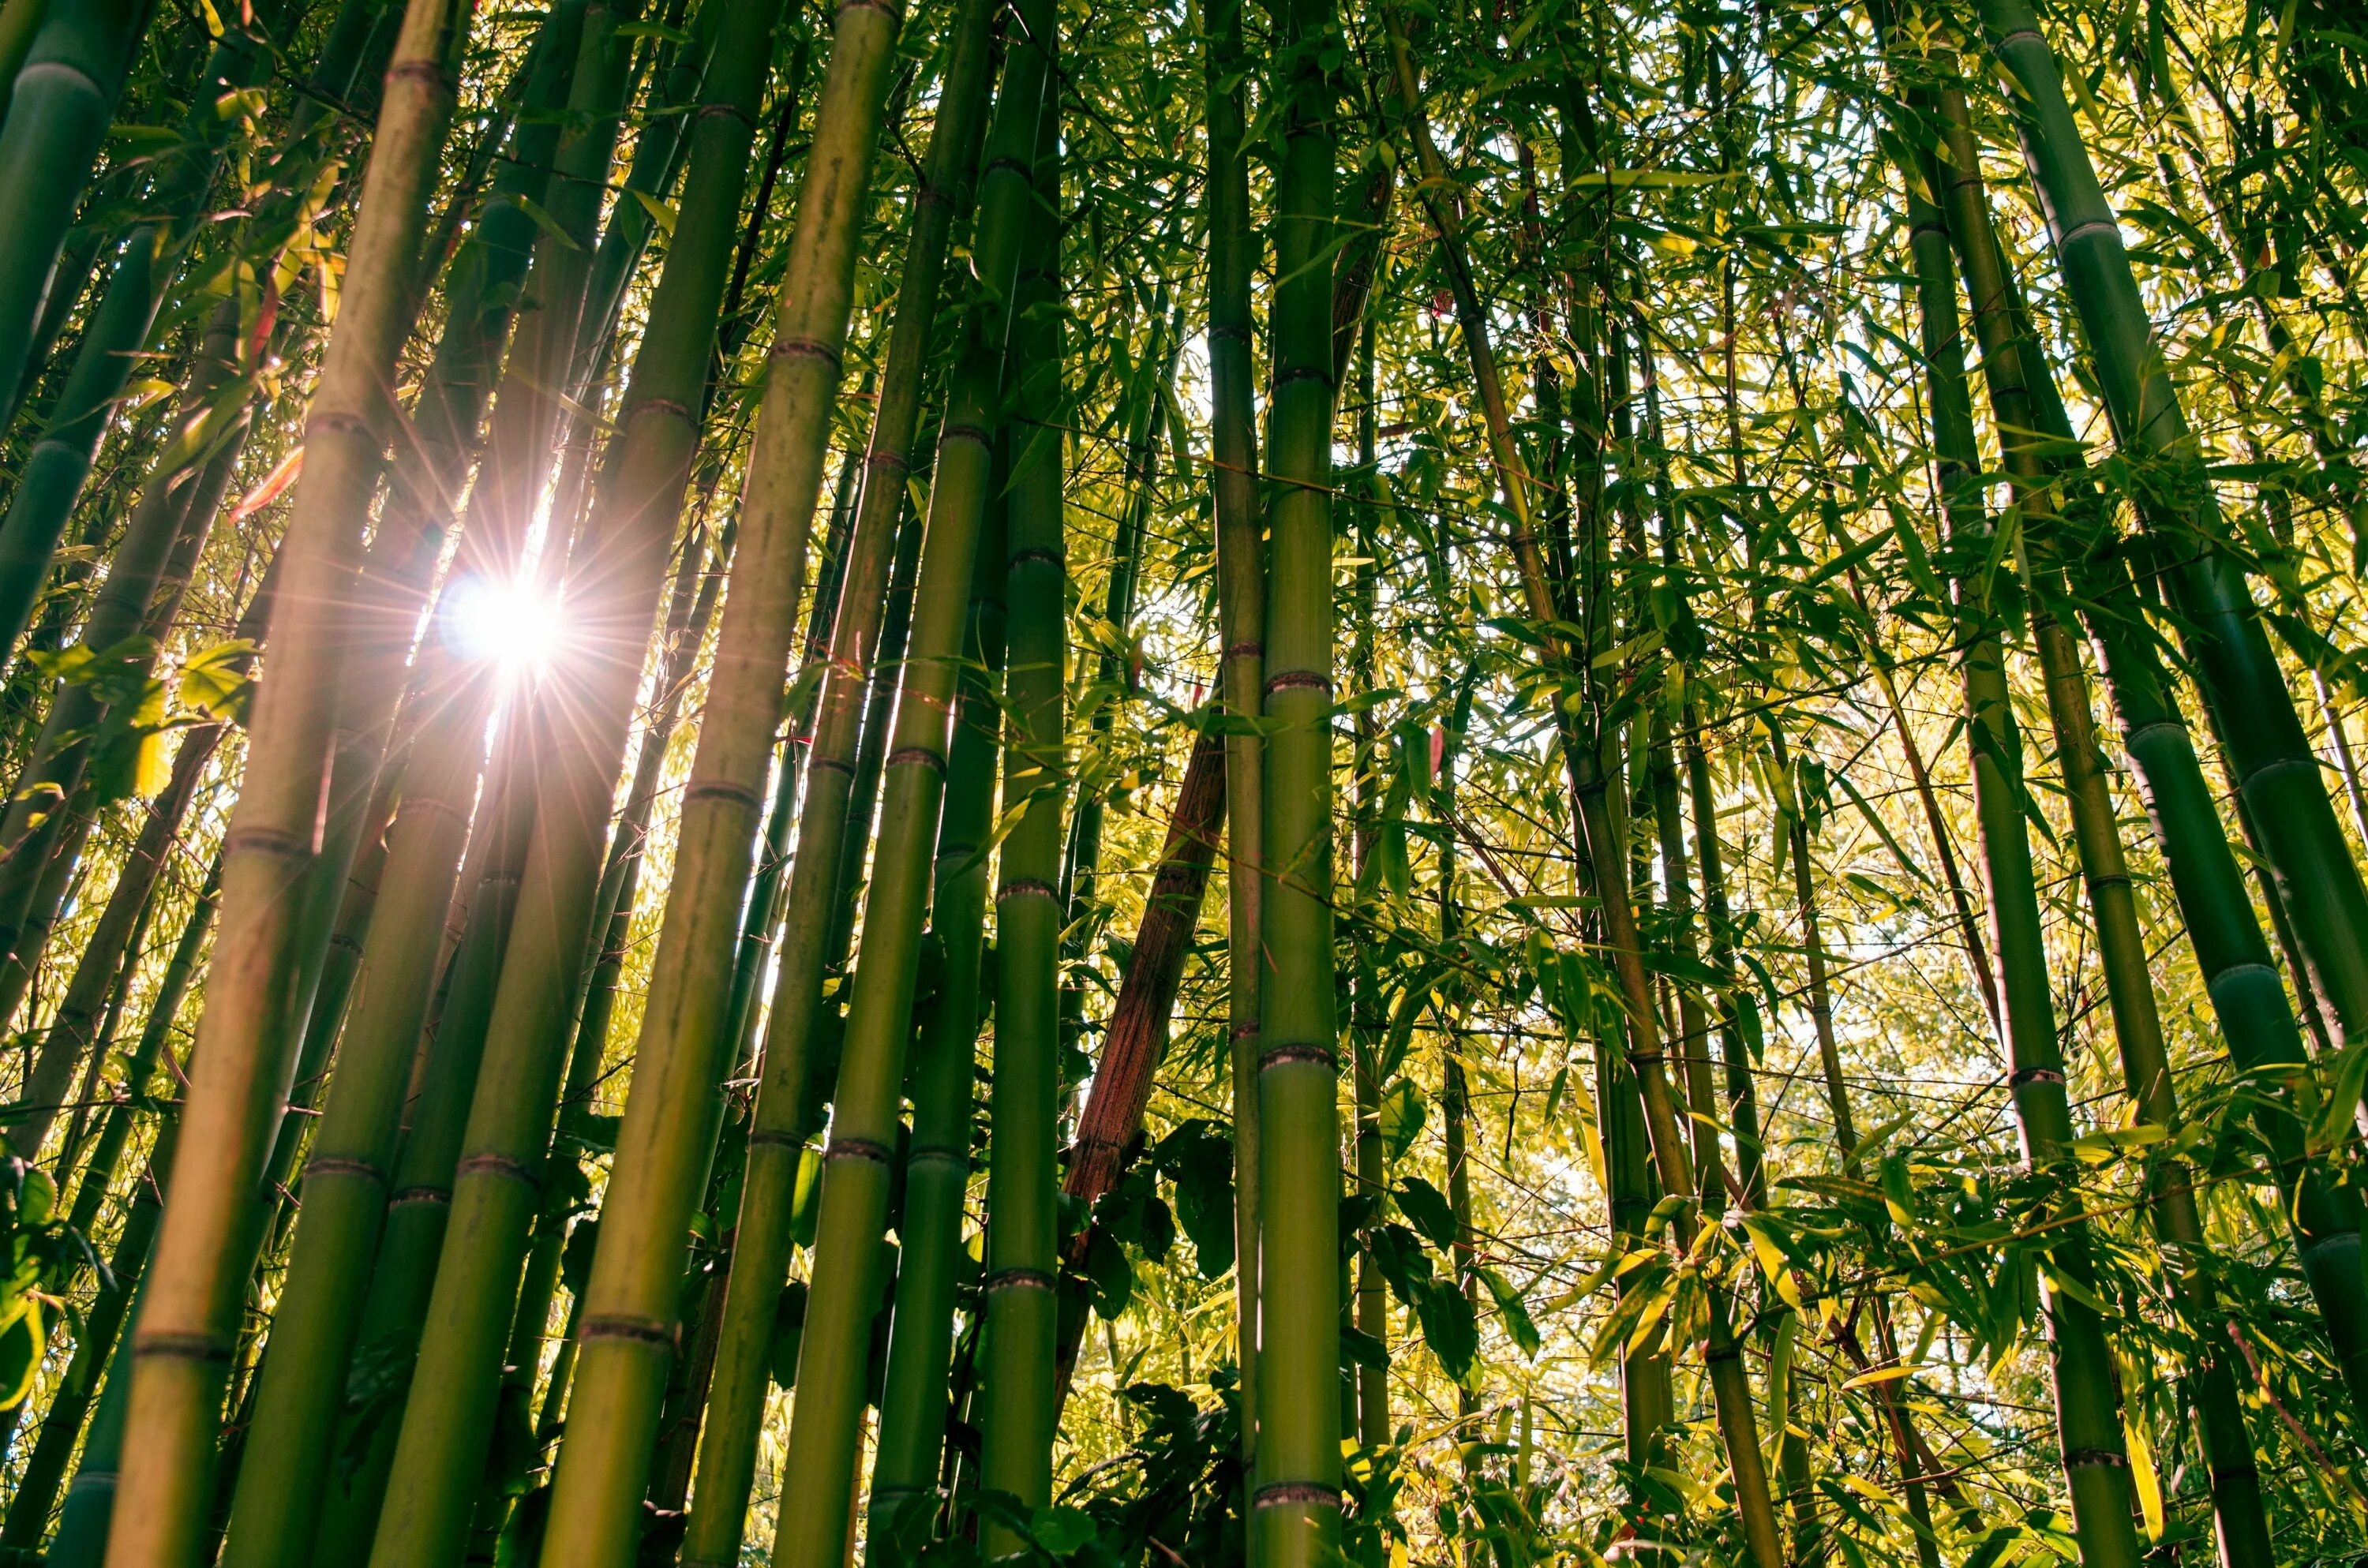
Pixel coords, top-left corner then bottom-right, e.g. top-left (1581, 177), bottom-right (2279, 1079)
top-left (1977, 0), bottom-right (2368, 1040)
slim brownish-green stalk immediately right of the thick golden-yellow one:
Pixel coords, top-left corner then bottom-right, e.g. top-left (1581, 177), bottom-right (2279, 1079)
top-left (682, 0), bottom-right (995, 1566)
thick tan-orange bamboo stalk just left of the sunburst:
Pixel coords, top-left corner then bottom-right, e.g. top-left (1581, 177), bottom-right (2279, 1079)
top-left (107, 0), bottom-right (469, 1568)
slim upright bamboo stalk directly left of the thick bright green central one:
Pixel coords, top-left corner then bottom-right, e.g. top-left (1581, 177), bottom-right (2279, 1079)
top-left (1205, 0), bottom-right (1267, 1458)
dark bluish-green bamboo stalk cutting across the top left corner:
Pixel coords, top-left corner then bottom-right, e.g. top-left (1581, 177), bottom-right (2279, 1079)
top-left (0, 0), bottom-right (154, 402)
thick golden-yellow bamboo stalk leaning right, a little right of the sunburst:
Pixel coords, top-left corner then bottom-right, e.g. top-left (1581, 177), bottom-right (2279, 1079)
top-left (542, 0), bottom-right (900, 1568)
